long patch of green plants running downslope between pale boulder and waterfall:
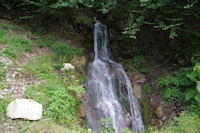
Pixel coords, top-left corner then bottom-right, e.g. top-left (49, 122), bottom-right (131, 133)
top-left (22, 55), bottom-right (84, 125)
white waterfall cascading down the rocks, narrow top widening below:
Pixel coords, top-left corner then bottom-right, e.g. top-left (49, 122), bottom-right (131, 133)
top-left (85, 20), bottom-right (144, 133)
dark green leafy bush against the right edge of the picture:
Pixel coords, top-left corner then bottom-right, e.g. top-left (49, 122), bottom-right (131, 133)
top-left (157, 58), bottom-right (200, 114)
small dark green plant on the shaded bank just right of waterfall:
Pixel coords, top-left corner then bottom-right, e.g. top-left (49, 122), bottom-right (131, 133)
top-left (133, 55), bottom-right (149, 73)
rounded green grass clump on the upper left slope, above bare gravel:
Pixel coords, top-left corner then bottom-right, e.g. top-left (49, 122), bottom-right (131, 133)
top-left (4, 36), bottom-right (34, 59)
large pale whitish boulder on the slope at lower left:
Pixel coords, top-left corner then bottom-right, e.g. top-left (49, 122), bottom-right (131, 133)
top-left (6, 99), bottom-right (42, 120)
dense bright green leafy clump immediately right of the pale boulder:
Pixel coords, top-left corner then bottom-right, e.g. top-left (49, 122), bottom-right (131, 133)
top-left (48, 88), bottom-right (79, 124)
